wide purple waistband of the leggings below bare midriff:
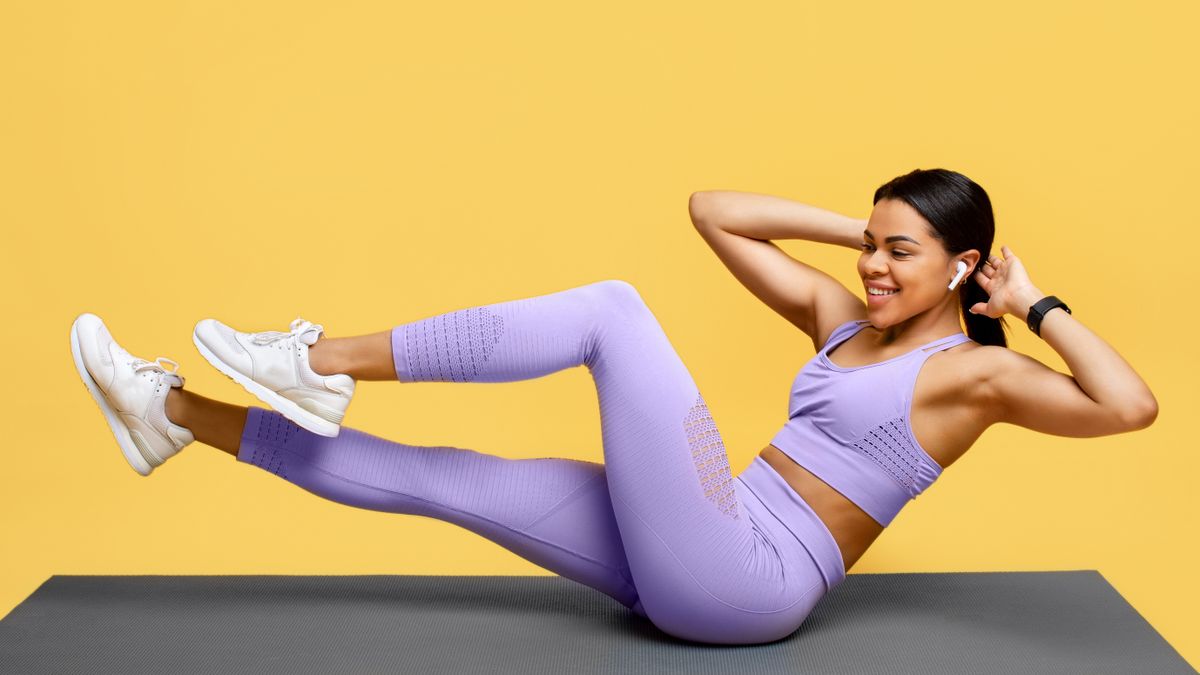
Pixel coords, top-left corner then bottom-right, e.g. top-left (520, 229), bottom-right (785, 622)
top-left (737, 456), bottom-right (846, 591)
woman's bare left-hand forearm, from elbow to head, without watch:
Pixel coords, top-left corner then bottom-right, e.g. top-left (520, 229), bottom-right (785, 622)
top-left (688, 190), bottom-right (866, 251)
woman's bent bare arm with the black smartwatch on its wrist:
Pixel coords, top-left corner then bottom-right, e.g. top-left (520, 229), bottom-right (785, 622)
top-left (972, 246), bottom-right (1158, 429)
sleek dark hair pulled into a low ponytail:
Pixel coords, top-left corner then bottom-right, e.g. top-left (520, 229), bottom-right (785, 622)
top-left (872, 168), bottom-right (1008, 347)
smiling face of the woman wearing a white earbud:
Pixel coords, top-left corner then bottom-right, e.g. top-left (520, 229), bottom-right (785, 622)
top-left (858, 199), bottom-right (973, 327)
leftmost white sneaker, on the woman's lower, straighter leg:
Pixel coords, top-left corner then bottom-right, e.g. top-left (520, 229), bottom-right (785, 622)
top-left (71, 313), bottom-right (196, 476)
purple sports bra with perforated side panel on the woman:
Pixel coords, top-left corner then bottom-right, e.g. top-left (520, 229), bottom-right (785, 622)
top-left (770, 319), bottom-right (970, 527)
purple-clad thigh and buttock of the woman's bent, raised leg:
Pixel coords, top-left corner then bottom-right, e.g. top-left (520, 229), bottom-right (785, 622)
top-left (586, 282), bottom-right (826, 644)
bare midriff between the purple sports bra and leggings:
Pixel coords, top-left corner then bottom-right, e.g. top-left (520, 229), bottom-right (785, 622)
top-left (758, 444), bottom-right (883, 571)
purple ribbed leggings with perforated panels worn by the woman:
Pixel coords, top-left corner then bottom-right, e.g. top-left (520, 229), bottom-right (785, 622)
top-left (238, 280), bottom-right (846, 644)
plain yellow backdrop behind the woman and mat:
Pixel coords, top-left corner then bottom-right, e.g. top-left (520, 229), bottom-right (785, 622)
top-left (0, 0), bottom-right (1200, 664)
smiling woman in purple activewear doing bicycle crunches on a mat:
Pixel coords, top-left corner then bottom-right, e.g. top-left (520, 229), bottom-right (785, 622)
top-left (71, 169), bottom-right (1157, 644)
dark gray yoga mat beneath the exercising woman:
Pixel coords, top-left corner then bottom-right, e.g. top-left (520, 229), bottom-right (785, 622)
top-left (0, 571), bottom-right (1195, 675)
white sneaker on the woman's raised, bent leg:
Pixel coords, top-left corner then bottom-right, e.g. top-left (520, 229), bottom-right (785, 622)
top-left (192, 317), bottom-right (354, 436)
